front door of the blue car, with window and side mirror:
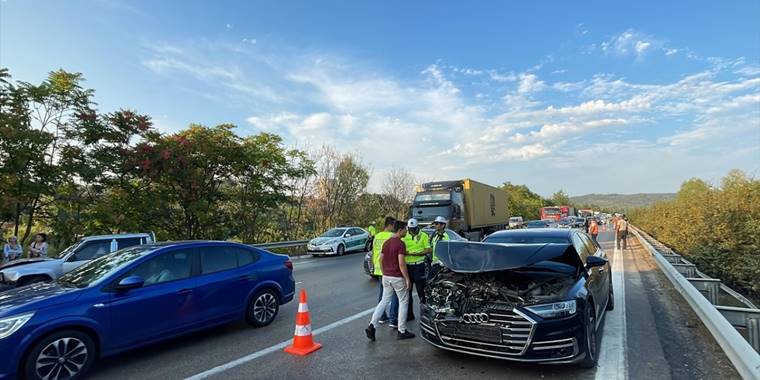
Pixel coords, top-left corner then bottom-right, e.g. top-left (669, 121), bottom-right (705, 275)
top-left (108, 248), bottom-right (199, 347)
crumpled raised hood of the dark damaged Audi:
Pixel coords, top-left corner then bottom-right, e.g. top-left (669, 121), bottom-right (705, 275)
top-left (435, 241), bottom-right (583, 273)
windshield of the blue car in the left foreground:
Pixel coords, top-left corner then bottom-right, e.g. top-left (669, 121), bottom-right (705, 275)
top-left (57, 246), bottom-right (154, 288)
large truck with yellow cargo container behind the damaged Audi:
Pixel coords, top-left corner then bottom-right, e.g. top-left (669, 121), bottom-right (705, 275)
top-left (410, 178), bottom-right (509, 240)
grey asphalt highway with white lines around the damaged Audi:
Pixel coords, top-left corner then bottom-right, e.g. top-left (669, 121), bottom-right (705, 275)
top-left (91, 231), bottom-right (740, 380)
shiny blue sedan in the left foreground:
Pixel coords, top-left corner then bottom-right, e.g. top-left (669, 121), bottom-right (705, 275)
top-left (0, 241), bottom-right (295, 379)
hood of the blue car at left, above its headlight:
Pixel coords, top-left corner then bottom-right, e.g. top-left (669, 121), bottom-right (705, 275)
top-left (0, 282), bottom-right (83, 316)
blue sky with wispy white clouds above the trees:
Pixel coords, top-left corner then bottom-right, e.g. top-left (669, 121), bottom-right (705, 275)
top-left (0, 0), bottom-right (760, 195)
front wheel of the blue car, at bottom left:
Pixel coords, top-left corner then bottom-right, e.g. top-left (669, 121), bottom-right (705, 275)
top-left (24, 330), bottom-right (97, 380)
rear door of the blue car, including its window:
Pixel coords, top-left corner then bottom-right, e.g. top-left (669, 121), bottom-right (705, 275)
top-left (197, 245), bottom-right (249, 322)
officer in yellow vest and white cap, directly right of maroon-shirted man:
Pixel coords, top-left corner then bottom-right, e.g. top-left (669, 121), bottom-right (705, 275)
top-left (400, 218), bottom-right (432, 321)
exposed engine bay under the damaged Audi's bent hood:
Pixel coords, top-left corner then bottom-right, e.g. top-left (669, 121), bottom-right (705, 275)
top-left (425, 269), bottom-right (575, 318)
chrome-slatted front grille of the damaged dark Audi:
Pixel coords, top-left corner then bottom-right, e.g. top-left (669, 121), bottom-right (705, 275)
top-left (430, 310), bottom-right (536, 356)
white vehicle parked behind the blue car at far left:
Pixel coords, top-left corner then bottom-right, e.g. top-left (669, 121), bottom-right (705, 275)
top-left (0, 233), bottom-right (156, 286)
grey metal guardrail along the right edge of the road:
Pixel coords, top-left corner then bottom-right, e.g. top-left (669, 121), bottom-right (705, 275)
top-left (631, 226), bottom-right (760, 379)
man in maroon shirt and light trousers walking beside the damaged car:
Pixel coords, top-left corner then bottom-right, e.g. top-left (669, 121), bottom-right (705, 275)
top-left (364, 221), bottom-right (415, 342)
